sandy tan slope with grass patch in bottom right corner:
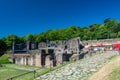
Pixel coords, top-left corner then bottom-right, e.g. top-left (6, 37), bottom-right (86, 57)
top-left (88, 56), bottom-right (120, 80)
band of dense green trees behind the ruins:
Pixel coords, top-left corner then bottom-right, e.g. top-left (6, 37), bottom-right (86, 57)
top-left (0, 18), bottom-right (120, 54)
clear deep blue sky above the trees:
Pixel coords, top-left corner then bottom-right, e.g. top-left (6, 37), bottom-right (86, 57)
top-left (0, 0), bottom-right (120, 38)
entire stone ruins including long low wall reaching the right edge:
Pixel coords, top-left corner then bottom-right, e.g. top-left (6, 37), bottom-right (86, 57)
top-left (11, 37), bottom-right (120, 67)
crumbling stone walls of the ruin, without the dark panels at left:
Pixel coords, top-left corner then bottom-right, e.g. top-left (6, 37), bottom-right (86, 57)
top-left (11, 37), bottom-right (81, 67)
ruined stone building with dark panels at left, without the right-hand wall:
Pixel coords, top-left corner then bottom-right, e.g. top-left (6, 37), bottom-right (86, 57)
top-left (11, 37), bottom-right (83, 67)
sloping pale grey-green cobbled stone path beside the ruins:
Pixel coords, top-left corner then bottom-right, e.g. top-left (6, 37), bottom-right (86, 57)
top-left (36, 51), bottom-right (116, 80)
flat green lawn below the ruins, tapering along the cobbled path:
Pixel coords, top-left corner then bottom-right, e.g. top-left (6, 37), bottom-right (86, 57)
top-left (0, 62), bottom-right (71, 80)
